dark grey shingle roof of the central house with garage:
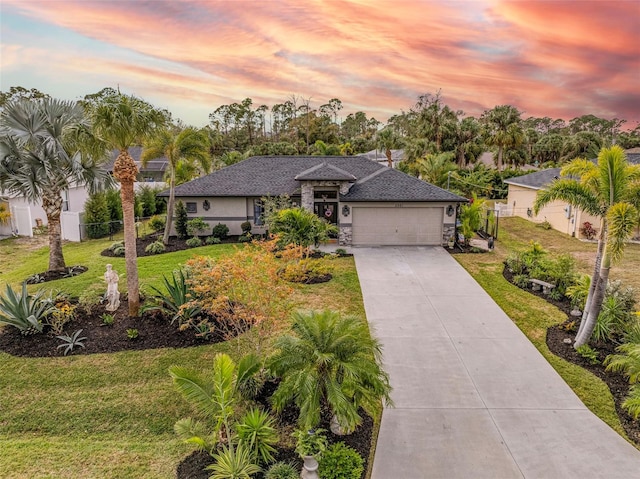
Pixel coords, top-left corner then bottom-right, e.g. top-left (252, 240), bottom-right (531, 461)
top-left (161, 156), bottom-right (466, 202)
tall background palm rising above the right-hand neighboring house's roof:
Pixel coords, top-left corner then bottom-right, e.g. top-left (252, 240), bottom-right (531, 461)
top-left (480, 105), bottom-right (524, 171)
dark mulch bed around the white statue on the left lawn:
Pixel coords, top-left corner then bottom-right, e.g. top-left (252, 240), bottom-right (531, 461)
top-left (0, 300), bottom-right (228, 357)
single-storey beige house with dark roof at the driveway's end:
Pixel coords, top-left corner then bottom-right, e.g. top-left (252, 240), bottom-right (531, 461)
top-left (161, 156), bottom-right (467, 245)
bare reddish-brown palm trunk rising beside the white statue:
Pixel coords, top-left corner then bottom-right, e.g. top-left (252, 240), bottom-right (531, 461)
top-left (113, 150), bottom-right (140, 317)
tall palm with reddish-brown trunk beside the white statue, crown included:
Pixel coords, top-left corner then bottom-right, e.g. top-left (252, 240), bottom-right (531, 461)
top-left (90, 93), bottom-right (167, 317)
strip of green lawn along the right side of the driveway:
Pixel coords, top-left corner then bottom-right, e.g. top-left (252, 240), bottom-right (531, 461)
top-left (456, 218), bottom-right (640, 438)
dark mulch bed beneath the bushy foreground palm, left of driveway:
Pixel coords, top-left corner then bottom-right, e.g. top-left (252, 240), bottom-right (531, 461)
top-left (177, 381), bottom-right (373, 479)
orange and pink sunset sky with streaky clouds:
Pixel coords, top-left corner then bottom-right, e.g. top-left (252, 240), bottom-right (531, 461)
top-left (0, 0), bottom-right (640, 127)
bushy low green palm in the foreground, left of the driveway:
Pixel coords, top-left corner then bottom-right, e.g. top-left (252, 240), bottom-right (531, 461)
top-left (268, 311), bottom-right (391, 431)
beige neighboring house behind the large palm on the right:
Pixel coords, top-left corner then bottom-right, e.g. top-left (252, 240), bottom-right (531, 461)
top-left (504, 148), bottom-right (640, 238)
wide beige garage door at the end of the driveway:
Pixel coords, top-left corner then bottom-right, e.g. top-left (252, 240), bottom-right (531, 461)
top-left (352, 207), bottom-right (444, 245)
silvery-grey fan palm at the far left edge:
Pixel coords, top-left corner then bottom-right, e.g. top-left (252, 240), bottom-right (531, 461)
top-left (0, 98), bottom-right (110, 271)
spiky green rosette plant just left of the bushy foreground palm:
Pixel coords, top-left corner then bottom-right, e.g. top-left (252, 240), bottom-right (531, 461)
top-left (236, 408), bottom-right (278, 464)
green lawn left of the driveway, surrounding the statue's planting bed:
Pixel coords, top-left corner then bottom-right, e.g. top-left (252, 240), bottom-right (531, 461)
top-left (0, 239), bottom-right (364, 479)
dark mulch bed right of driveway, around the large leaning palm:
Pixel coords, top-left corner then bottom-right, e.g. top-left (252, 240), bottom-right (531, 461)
top-left (503, 267), bottom-right (640, 445)
